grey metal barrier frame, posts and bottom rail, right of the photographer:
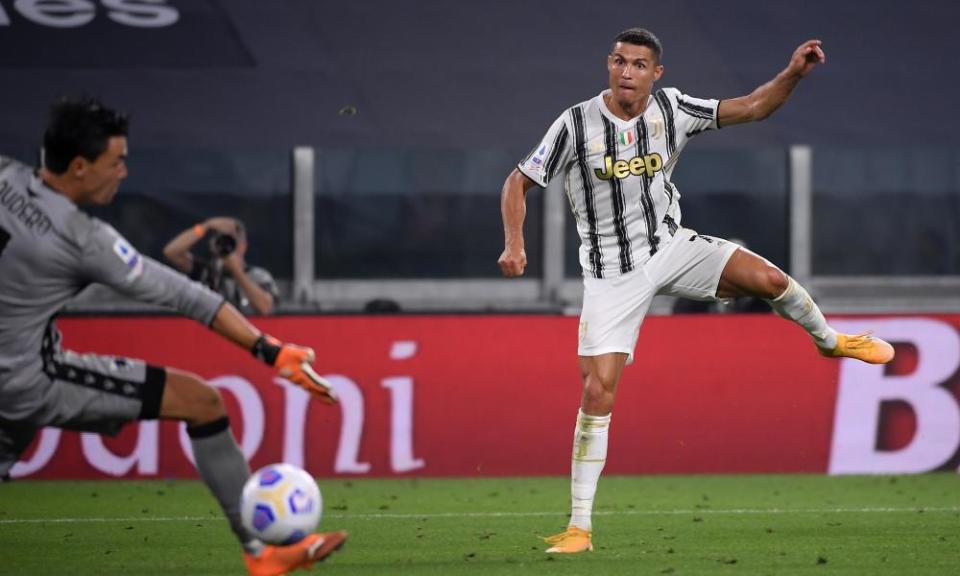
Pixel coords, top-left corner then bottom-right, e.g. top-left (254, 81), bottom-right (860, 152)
top-left (293, 146), bottom-right (960, 314)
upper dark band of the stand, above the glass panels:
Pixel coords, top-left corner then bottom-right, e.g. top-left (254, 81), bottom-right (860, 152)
top-left (0, 0), bottom-right (960, 149)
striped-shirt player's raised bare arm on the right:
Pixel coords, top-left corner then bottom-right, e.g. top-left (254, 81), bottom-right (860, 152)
top-left (717, 40), bottom-right (827, 126)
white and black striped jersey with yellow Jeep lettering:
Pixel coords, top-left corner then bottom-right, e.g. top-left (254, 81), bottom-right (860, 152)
top-left (517, 88), bottom-right (719, 278)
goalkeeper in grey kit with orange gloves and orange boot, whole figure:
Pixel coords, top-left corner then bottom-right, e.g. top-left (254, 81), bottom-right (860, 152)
top-left (0, 99), bottom-right (346, 576)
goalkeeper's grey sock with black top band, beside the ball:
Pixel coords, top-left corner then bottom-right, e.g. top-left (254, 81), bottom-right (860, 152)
top-left (187, 416), bottom-right (263, 555)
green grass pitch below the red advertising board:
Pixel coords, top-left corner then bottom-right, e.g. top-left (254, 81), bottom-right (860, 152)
top-left (0, 473), bottom-right (960, 576)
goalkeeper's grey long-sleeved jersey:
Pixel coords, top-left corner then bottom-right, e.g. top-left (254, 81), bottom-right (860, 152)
top-left (0, 156), bottom-right (223, 402)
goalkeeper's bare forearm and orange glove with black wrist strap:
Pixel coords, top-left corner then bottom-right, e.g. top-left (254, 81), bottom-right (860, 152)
top-left (210, 302), bottom-right (337, 404)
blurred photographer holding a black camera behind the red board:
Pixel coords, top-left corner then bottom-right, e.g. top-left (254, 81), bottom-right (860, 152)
top-left (163, 217), bottom-right (278, 315)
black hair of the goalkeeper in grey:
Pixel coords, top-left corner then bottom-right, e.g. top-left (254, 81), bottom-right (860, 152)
top-left (43, 97), bottom-right (129, 174)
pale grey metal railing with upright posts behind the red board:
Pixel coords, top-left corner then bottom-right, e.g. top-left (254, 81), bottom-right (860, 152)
top-left (65, 146), bottom-right (960, 314)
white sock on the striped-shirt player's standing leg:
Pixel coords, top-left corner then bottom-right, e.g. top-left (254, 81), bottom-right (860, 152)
top-left (570, 410), bottom-right (610, 532)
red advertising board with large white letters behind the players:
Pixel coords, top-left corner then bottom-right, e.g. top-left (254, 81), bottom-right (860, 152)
top-left (14, 315), bottom-right (960, 478)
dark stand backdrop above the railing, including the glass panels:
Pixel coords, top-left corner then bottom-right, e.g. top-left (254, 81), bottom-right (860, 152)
top-left (0, 0), bottom-right (960, 294)
